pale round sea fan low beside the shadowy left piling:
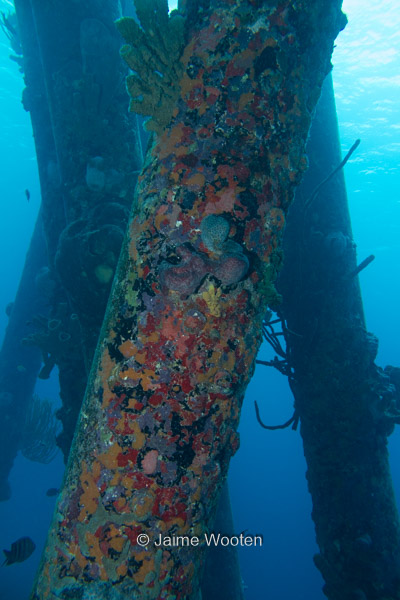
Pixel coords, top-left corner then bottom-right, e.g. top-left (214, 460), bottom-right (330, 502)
top-left (20, 394), bottom-right (58, 464)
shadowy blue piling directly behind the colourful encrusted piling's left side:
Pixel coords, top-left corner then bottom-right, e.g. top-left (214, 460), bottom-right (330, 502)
top-left (10, 0), bottom-right (142, 460)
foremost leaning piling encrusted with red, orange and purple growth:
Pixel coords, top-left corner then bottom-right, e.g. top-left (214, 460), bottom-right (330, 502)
top-left (31, 0), bottom-right (345, 600)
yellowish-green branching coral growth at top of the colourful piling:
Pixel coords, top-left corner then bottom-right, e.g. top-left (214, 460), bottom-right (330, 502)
top-left (116, 0), bottom-right (184, 133)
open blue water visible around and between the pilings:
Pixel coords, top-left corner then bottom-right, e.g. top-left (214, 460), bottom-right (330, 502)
top-left (0, 0), bottom-right (400, 600)
